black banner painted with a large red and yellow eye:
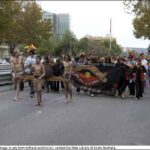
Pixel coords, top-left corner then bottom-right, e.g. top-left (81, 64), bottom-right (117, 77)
top-left (72, 63), bottom-right (122, 95)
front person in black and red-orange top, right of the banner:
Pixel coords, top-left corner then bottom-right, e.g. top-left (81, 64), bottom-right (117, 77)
top-left (134, 58), bottom-right (146, 99)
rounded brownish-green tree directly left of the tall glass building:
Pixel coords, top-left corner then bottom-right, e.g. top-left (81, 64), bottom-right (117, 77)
top-left (21, 1), bottom-right (51, 47)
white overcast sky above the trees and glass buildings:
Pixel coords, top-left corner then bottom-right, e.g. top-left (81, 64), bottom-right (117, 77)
top-left (38, 1), bottom-right (150, 48)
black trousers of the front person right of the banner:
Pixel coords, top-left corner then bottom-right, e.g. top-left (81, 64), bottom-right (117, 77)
top-left (135, 81), bottom-right (143, 98)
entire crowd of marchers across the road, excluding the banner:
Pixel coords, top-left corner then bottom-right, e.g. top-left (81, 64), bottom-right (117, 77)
top-left (10, 50), bottom-right (150, 106)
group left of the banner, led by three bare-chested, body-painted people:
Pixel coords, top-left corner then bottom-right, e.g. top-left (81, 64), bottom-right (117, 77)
top-left (10, 50), bottom-right (73, 106)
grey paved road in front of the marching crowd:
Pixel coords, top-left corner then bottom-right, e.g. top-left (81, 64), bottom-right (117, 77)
top-left (0, 88), bottom-right (150, 145)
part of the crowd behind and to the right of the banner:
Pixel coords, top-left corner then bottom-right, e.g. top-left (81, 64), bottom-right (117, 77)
top-left (74, 53), bottom-right (150, 99)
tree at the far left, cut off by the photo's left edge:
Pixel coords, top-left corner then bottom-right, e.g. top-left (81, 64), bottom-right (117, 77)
top-left (0, 0), bottom-right (21, 48)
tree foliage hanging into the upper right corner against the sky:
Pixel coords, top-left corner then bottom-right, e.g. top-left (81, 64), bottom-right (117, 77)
top-left (124, 0), bottom-right (150, 39)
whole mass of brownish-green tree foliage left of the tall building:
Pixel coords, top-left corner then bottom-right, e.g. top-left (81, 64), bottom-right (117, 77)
top-left (0, 0), bottom-right (51, 52)
